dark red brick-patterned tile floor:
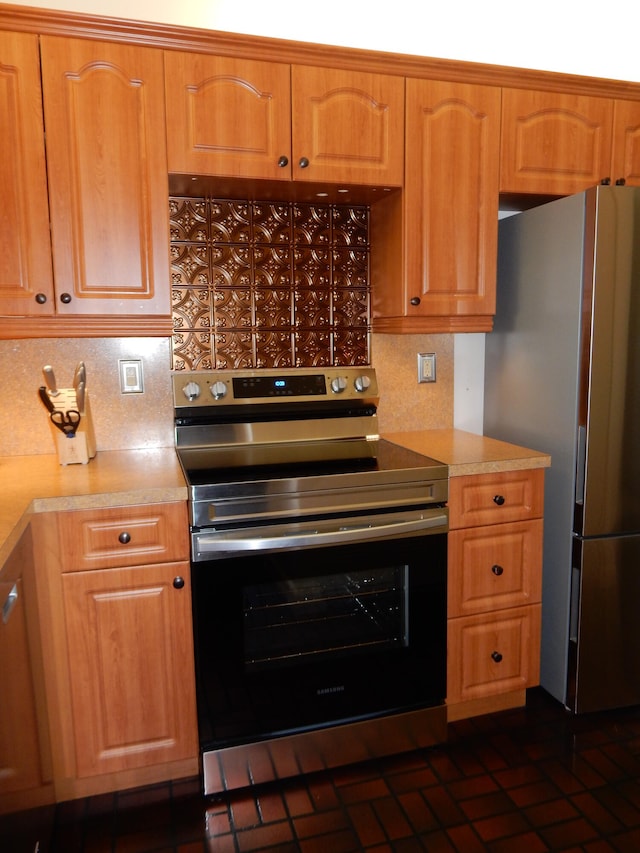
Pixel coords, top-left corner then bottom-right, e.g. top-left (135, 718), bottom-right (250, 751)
top-left (3, 690), bottom-right (640, 853)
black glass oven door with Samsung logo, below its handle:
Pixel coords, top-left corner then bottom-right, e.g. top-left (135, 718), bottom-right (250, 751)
top-left (192, 524), bottom-right (447, 750)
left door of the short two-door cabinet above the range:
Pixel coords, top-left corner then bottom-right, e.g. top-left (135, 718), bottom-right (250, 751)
top-left (165, 51), bottom-right (291, 180)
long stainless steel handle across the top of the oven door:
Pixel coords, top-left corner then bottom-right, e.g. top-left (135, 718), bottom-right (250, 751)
top-left (194, 510), bottom-right (448, 557)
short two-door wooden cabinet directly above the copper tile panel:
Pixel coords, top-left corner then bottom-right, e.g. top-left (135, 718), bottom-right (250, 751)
top-left (165, 57), bottom-right (404, 186)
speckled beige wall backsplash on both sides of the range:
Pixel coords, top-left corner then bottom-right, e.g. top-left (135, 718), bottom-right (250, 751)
top-left (0, 335), bottom-right (453, 456)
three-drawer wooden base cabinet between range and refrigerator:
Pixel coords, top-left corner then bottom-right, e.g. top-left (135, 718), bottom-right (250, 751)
top-left (447, 469), bottom-right (544, 721)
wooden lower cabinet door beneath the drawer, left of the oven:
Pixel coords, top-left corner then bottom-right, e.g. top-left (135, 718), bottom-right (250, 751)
top-left (63, 563), bottom-right (197, 777)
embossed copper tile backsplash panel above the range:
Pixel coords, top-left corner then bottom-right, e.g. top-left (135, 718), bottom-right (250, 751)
top-left (169, 197), bottom-right (370, 370)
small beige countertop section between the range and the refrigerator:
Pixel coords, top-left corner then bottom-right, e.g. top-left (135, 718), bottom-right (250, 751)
top-left (382, 429), bottom-right (551, 477)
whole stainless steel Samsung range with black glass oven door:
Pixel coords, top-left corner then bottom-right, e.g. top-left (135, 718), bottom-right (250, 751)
top-left (173, 368), bottom-right (448, 794)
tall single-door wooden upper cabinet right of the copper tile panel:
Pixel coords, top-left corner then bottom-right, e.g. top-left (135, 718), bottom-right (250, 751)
top-left (371, 79), bottom-right (500, 333)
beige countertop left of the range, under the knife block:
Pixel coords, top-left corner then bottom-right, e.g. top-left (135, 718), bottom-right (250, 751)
top-left (0, 447), bottom-right (188, 569)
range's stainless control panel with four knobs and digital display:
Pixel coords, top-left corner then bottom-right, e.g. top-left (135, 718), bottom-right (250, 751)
top-left (173, 367), bottom-right (378, 408)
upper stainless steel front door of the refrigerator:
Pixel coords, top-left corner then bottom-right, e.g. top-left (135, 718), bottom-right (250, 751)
top-left (574, 187), bottom-right (640, 536)
